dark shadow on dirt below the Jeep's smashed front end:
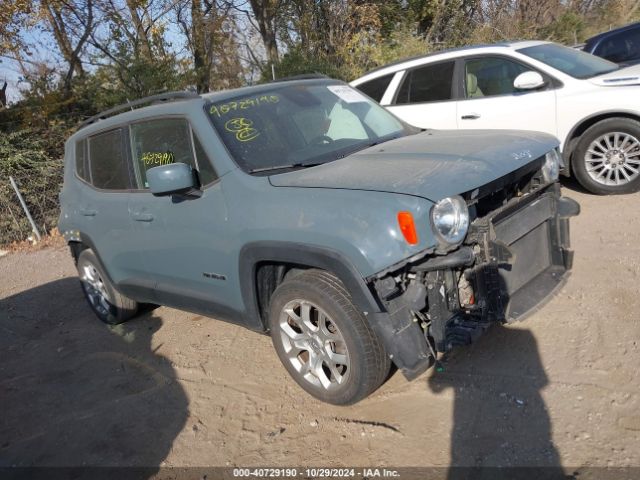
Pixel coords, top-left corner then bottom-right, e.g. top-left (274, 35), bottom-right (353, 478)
top-left (428, 326), bottom-right (566, 480)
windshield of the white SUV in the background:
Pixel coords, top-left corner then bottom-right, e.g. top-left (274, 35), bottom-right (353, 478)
top-left (518, 43), bottom-right (619, 79)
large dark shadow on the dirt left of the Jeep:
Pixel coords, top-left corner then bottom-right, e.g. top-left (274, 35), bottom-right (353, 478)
top-left (0, 278), bottom-right (188, 467)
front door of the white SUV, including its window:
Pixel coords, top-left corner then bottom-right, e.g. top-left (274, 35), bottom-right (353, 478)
top-left (457, 56), bottom-right (558, 136)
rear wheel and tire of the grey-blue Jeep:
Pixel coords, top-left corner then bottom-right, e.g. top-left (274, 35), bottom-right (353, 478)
top-left (77, 249), bottom-right (138, 325)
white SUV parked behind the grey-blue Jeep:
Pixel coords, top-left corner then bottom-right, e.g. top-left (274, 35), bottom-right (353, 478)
top-left (351, 41), bottom-right (640, 194)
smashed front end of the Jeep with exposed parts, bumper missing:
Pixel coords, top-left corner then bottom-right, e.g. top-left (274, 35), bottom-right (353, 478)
top-left (370, 184), bottom-right (580, 379)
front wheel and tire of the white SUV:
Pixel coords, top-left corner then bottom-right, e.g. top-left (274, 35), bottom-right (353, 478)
top-left (571, 118), bottom-right (640, 195)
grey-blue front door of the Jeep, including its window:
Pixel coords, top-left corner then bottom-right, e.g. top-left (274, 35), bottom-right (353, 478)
top-left (124, 118), bottom-right (233, 317)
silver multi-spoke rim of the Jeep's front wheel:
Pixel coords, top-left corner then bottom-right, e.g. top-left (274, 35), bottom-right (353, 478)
top-left (279, 300), bottom-right (350, 390)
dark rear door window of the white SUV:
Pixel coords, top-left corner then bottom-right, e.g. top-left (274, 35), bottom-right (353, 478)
top-left (396, 62), bottom-right (455, 104)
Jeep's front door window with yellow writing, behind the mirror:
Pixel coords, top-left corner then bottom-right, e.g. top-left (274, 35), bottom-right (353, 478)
top-left (130, 118), bottom-right (198, 188)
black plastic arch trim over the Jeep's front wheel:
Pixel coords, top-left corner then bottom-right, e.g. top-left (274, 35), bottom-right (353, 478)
top-left (239, 241), bottom-right (382, 331)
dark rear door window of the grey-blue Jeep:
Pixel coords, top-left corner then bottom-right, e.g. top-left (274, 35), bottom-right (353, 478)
top-left (89, 129), bottom-right (130, 190)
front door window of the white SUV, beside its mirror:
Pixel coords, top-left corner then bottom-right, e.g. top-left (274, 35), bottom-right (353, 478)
top-left (464, 57), bottom-right (531, 98)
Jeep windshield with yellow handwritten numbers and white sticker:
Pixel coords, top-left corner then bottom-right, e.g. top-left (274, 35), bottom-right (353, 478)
top-left (205, 81), bottom-right (419, 173)
